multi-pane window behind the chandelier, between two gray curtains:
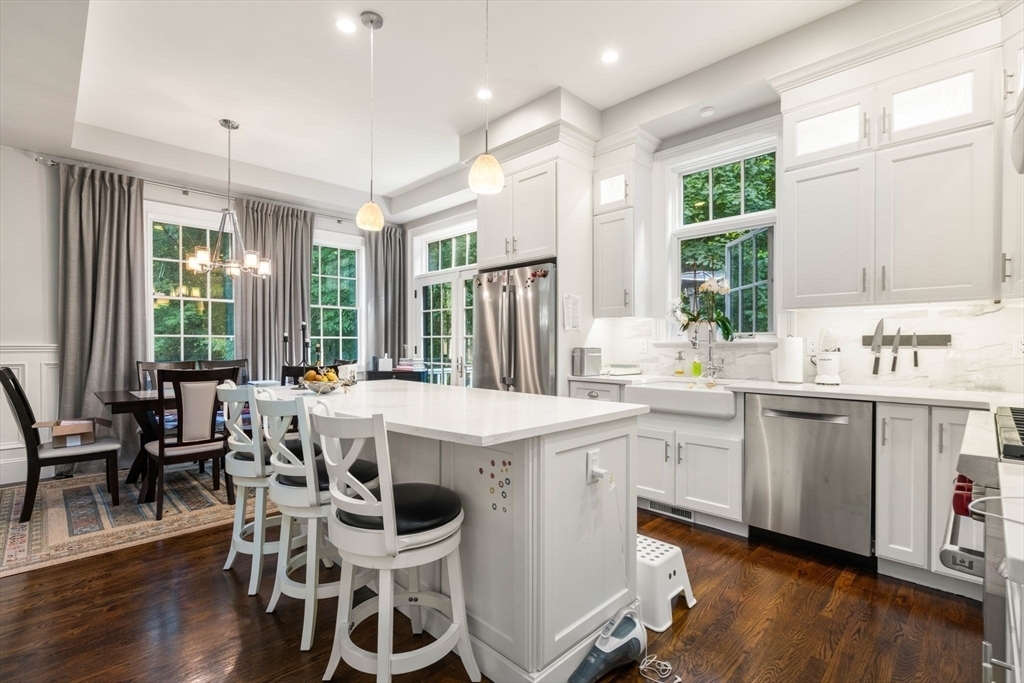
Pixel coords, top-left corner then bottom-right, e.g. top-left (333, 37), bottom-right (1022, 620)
top-left (151, 221), bottom-right (234, 360)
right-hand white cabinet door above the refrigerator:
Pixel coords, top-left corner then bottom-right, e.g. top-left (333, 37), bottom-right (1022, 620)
top-left (512, 162), bottom-right (557, 261)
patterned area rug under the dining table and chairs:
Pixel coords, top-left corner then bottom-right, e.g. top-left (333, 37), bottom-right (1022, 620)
top-left (0, 463), bottom-right (274, 578)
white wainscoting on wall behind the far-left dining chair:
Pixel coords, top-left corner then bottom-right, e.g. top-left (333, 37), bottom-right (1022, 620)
top-left (0, 344), bottom-right (60, 485)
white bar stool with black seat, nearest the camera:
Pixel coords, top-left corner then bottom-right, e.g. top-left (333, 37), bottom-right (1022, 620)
top-left (309, 401), bottom-right (480, 681)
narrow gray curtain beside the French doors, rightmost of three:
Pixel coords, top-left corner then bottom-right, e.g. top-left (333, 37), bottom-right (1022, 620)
top-left (367, 225), bottom-right (408, 361)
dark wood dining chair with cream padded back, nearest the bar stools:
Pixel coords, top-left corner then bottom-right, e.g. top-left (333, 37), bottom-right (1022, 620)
top-left (145, 368), bottom-right (237, 519)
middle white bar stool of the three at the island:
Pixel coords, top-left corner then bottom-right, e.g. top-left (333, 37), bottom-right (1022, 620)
top-left (260, 390), bottom-right (377, 650)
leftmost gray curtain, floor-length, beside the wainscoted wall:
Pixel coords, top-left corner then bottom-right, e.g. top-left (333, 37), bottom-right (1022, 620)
top-left (57, 164), bottom-right (148, 474)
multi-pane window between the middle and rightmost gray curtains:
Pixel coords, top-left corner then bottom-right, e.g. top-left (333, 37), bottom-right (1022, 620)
top-left (309, 245), bottom-right (359, 364)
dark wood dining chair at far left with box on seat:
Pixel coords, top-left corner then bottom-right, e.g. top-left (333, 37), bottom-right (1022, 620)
top-left (0, 367), bottom-right (121, 524)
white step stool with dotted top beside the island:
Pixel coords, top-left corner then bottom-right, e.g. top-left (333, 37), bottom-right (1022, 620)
top-left (637, 533), bottom-right (697, 633)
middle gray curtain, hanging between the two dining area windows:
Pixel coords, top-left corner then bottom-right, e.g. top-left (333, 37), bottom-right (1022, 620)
top-left (234, 200), bottom-right (313, 380)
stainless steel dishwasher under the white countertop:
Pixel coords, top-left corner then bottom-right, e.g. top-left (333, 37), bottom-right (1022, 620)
top-left (743, 394), bottom-right (874, 556)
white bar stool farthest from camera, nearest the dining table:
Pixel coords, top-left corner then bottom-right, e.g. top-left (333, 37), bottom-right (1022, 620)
top-left (217, 380), bottom-right (282, 595)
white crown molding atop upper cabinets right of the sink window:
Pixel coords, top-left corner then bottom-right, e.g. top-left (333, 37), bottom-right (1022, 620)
top-left (768, 0), bottom-right (999, 93)
